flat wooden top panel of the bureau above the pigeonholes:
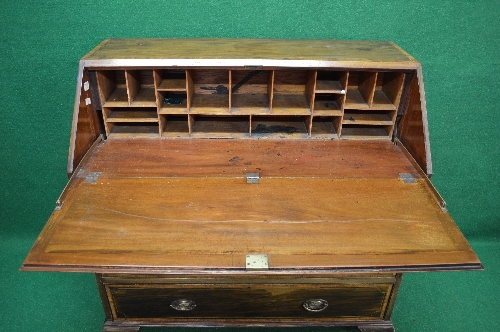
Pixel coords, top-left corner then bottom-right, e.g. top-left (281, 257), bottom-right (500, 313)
top-left (82, 38), bottom-right (418, 67)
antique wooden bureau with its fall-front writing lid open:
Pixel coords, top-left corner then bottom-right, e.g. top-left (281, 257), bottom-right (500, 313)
top-left (22, 39), bottom-right (482, 331)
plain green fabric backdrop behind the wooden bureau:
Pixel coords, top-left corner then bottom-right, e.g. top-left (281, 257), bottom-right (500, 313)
top-left (0, 0), bottom-right (500, 332)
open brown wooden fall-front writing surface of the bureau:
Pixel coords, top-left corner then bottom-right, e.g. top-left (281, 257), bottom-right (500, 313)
top-left (22, 139), bottom-right (482, 273)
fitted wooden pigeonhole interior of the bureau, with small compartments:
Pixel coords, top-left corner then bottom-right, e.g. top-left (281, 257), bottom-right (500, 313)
top-left (96, 68), bottom-right (405, 139)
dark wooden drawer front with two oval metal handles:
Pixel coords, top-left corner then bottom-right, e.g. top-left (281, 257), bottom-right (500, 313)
top-left (106, 284), bottom-right (393, 319)
